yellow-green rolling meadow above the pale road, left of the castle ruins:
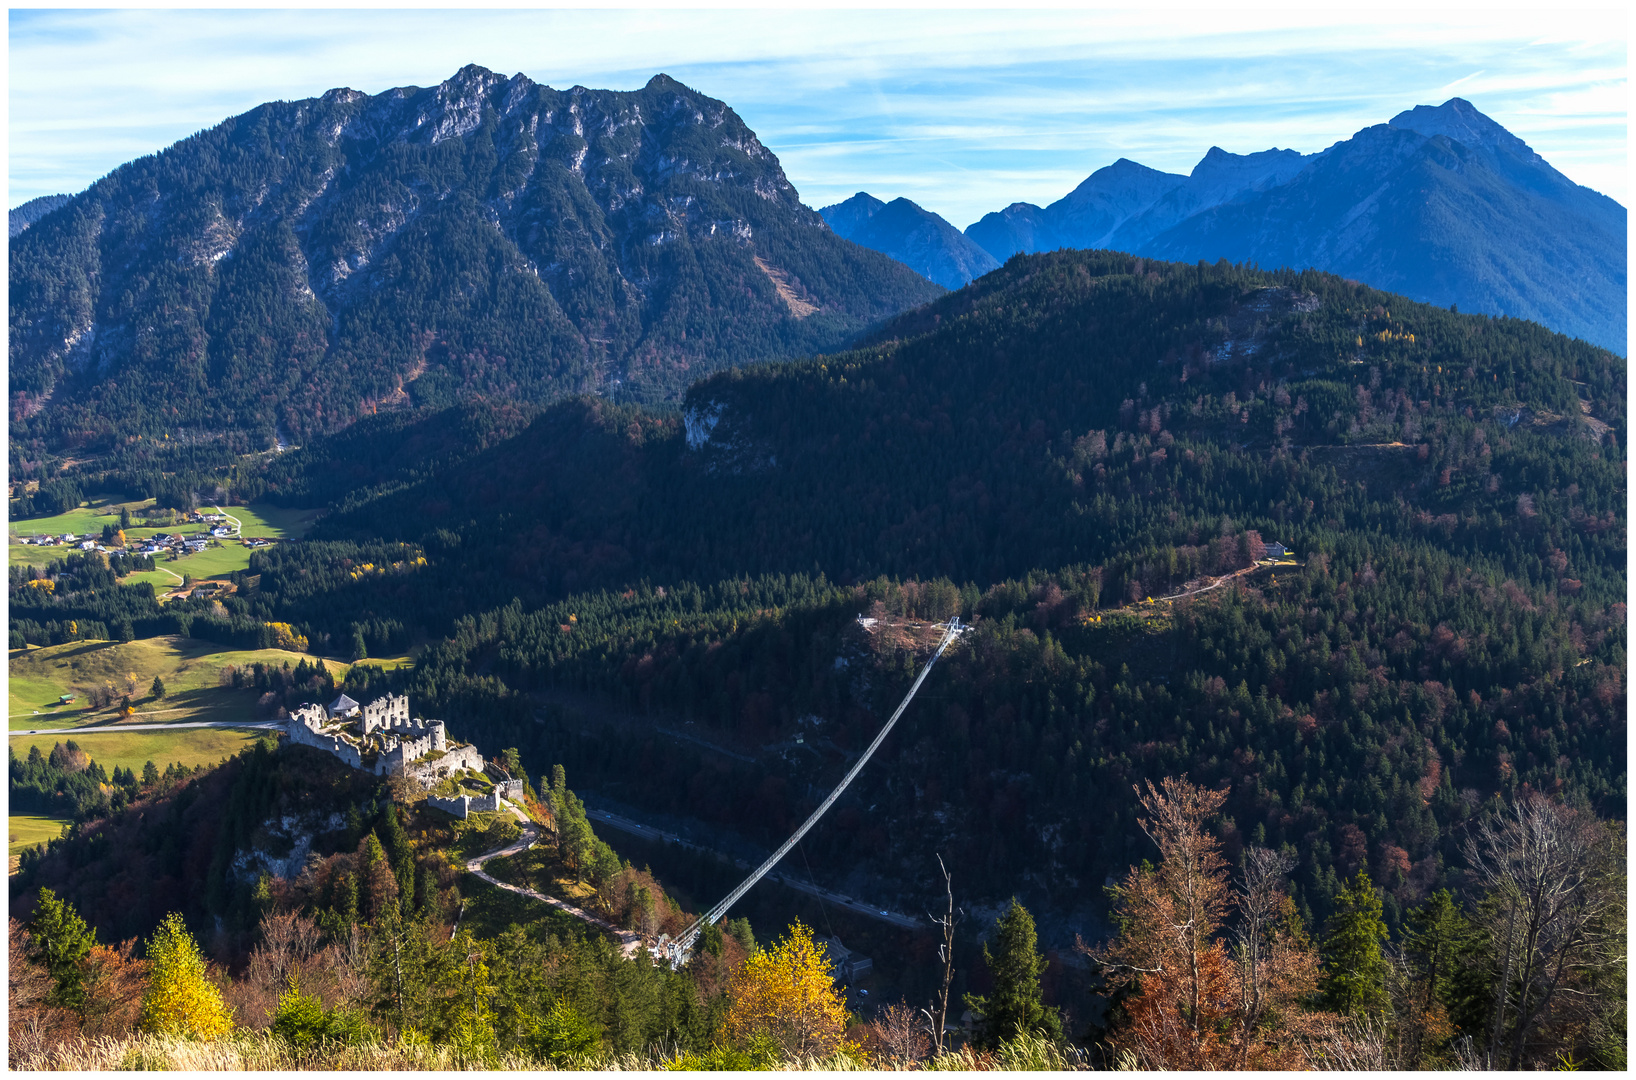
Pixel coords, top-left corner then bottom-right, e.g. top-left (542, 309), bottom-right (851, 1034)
top-left (7, 635), bottom-right (397, 731)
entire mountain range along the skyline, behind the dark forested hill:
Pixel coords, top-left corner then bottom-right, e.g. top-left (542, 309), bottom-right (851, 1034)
top-left (10, 81), bottom-right (1626, 468)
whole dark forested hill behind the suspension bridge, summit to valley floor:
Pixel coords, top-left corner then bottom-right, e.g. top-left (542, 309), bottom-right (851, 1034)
top-left (33, 252), bottom-right (1626, 936)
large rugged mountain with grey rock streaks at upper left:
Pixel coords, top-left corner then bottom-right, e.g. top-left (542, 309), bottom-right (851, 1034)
top-left (10, 65), bottom-right (941, 448)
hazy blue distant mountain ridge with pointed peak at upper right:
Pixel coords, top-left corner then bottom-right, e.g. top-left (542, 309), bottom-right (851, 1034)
top-left (965, 98), bottom-right (1628, 355)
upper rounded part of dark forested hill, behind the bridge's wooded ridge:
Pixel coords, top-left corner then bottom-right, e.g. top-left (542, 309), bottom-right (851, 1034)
top-left (281, 254), bottom-right (1625, 614)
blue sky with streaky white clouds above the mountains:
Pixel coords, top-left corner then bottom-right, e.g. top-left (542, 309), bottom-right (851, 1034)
top-left (7, 3), bottom-right (1628, 227)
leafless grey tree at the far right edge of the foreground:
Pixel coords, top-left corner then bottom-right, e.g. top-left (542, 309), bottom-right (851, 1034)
top-left (1464, 792), bottom-right (1625, 1069)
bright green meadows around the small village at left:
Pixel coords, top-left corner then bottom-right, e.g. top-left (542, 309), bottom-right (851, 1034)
top-left (8, 496), bottom-right (319, 587)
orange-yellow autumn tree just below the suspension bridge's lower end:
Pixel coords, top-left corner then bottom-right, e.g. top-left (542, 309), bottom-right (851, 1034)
top-left (726, 920), bottom-right (847, 1057)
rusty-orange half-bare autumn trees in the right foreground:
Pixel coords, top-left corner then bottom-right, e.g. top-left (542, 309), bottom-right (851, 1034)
top-left (1081, 777), bottom-right (1324, 1069)
